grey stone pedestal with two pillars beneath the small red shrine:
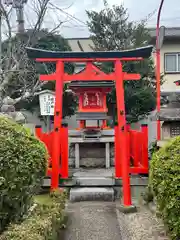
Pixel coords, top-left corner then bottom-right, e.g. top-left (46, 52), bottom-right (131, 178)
top-left (69, 130), bottom-right (114, 168)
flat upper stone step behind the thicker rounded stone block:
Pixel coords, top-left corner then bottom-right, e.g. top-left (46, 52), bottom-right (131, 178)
top-left (73, 176), bottom-right (115, 186)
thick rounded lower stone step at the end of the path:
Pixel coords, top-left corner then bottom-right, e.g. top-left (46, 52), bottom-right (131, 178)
top-left (69, 187), bottom-right (114, 202)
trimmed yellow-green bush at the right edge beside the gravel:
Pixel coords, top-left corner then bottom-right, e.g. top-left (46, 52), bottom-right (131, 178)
top-left (150, 136), bottom-right (180, 240)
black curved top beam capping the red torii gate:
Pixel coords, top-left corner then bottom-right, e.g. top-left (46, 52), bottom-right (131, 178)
top-left (26, 45), bottom-right (153, 59)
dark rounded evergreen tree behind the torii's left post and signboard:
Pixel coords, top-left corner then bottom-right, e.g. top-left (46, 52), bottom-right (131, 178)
top-left (3, 30), bottom-right (76, 117)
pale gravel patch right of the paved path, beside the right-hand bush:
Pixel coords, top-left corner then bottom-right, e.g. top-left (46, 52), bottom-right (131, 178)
top-left (116, 202), bottom-right (169, 240)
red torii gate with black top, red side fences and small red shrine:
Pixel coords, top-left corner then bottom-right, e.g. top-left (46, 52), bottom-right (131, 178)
top-left (27, 46), bottom-right (153, 206)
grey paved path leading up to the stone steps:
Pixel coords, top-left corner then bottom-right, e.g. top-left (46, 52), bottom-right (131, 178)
top-left (64, 202), bottom-right (122, 240)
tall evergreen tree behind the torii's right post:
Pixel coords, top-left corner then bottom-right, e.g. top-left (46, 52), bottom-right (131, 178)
top-left (87, 1), bottom-right (160, 122)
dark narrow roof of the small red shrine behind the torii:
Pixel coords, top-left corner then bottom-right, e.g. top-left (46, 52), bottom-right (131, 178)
top-left (69, 81), bottom-right (114, 88)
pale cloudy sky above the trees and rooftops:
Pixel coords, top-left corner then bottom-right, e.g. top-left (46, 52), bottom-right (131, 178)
top-left (6, 0), bottom-right (180, 38)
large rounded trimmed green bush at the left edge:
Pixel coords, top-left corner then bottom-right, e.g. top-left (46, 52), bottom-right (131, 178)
top-left (0, 117), bottom-right (48, 232)
